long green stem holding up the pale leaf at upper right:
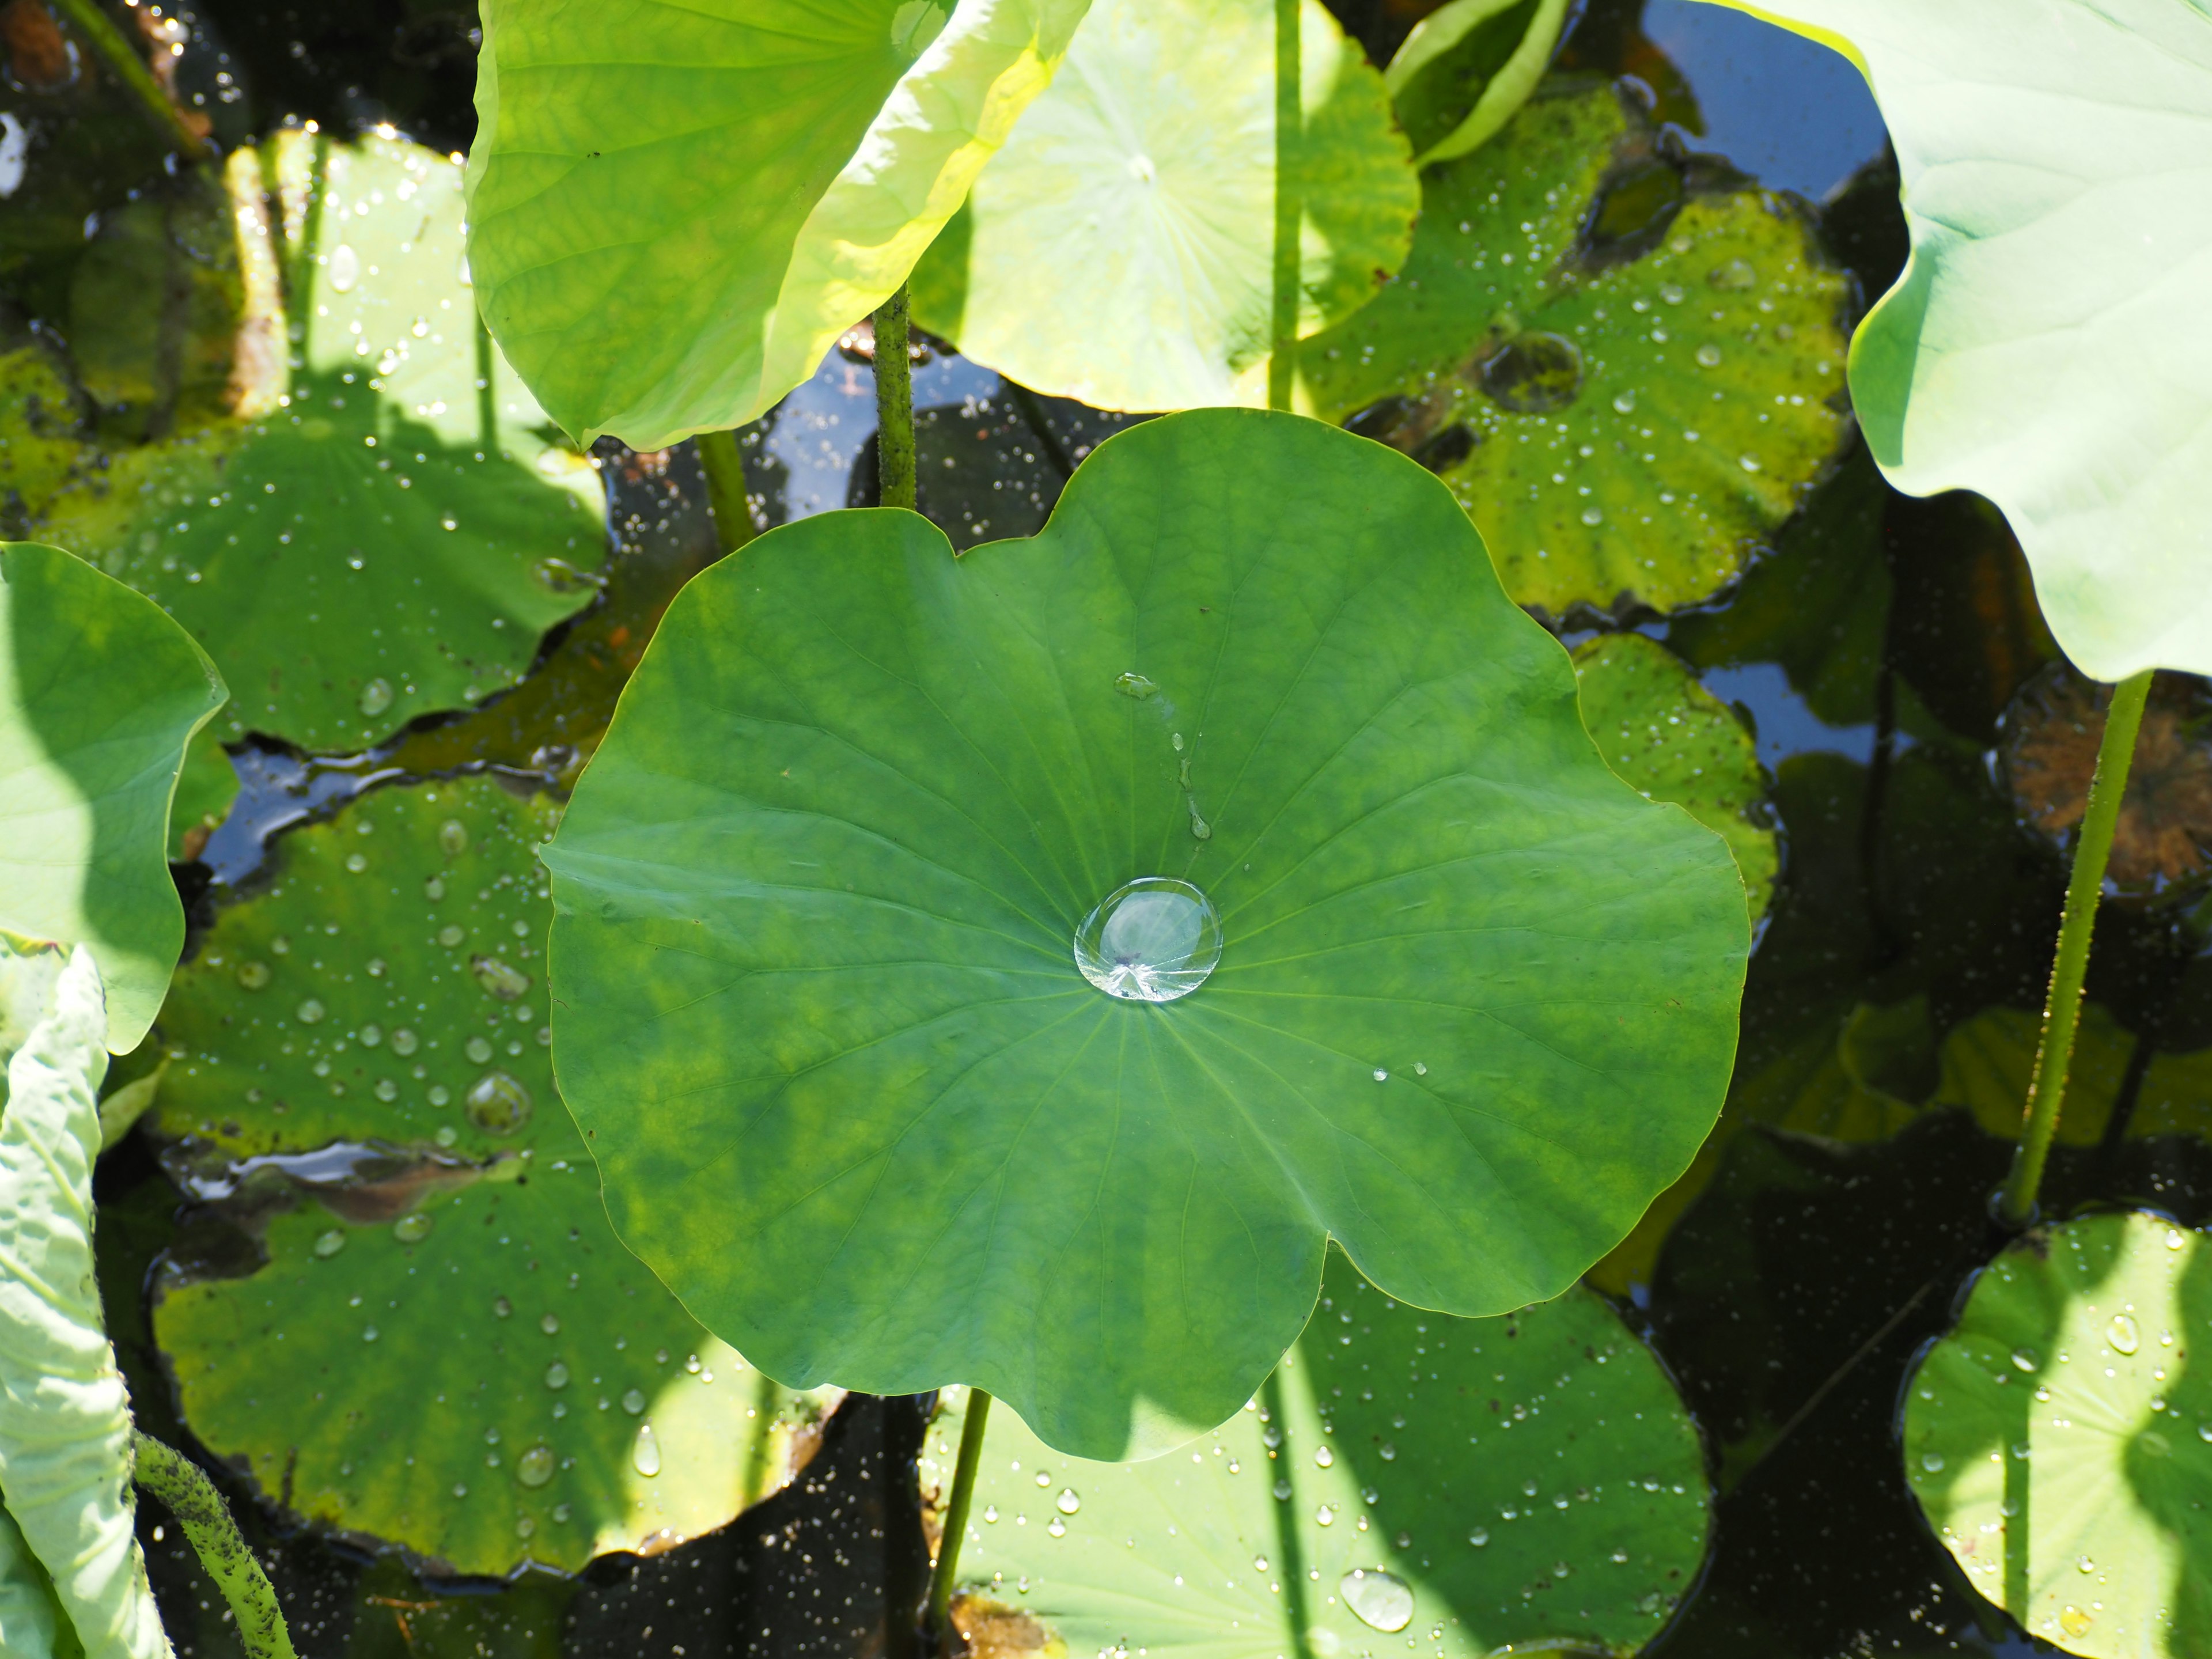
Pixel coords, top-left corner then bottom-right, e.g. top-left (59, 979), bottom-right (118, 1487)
top-left (1998, 668), bottom-right (2152, 1228)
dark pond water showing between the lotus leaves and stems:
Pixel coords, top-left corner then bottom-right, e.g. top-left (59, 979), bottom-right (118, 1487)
top-left (7, 0), bottom-right (2212, 1659)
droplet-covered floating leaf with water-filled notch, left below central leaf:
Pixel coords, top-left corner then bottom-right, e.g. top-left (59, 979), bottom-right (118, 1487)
top-left (150, 777), bottom-right (840, 1573)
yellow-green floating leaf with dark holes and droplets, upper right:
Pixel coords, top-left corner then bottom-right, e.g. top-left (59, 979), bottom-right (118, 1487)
top-left (1298, 84), bottom-right (1849, 615)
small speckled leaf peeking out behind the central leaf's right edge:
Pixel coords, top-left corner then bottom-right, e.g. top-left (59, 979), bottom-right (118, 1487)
top-left (1575, 632), bottom-right (1781, 922)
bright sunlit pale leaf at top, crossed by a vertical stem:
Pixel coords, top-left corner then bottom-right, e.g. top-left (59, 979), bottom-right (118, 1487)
top-left (914, 0), bottom-right (1420, 409)
